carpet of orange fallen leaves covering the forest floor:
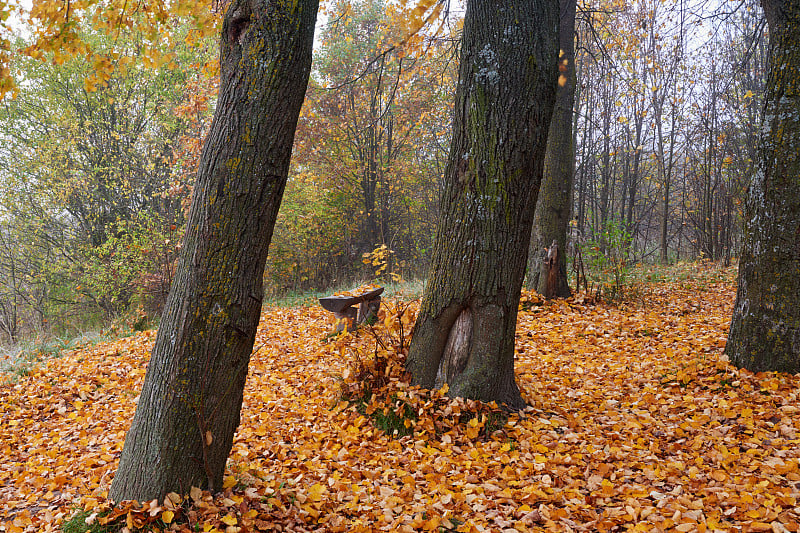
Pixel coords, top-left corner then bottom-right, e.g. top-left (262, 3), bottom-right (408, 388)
top-left (0, 268), bottom-right (800, 533)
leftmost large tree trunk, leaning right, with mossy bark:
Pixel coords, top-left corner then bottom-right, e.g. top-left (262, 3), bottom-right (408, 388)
top-left (110, 0), bottom-right (318, 501)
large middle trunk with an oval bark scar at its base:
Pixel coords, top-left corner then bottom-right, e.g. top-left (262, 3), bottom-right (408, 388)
top-left (407, 0), bottom-right (558, 409)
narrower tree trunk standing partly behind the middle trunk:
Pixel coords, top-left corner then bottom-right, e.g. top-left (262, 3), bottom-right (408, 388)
top-left (528, 0), bottom-right (577, 298)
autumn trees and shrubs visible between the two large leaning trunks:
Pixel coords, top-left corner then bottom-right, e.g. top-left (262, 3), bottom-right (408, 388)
top-left (268, 0), bottom-right (457, 288)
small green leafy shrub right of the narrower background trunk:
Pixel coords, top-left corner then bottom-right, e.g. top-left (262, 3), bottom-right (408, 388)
top-left (582, 219), bottom-right (632, 300)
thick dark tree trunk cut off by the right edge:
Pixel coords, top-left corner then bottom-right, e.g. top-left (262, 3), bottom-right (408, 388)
top-left (726, 0), bottom-right (800, 373)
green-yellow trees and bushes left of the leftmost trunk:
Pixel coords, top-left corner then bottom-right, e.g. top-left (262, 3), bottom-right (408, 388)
top-left (0, 20), bottom-right (212, 343)
